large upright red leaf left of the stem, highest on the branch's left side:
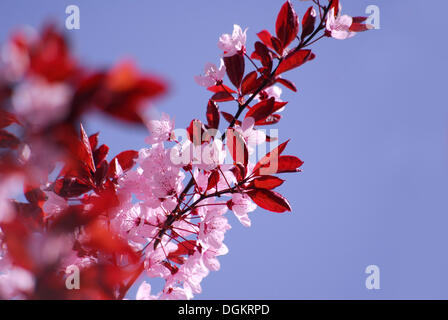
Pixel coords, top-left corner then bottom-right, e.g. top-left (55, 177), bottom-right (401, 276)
top-left (275, 1), bottom-right (299, 48)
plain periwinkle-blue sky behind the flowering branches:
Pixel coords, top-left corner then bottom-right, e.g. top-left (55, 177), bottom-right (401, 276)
top-left (0, 0), bottom-right (448, 299)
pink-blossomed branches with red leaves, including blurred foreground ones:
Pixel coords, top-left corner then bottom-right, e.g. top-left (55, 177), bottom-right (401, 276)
top-left (0, 0), bottom-right (369, 299)
